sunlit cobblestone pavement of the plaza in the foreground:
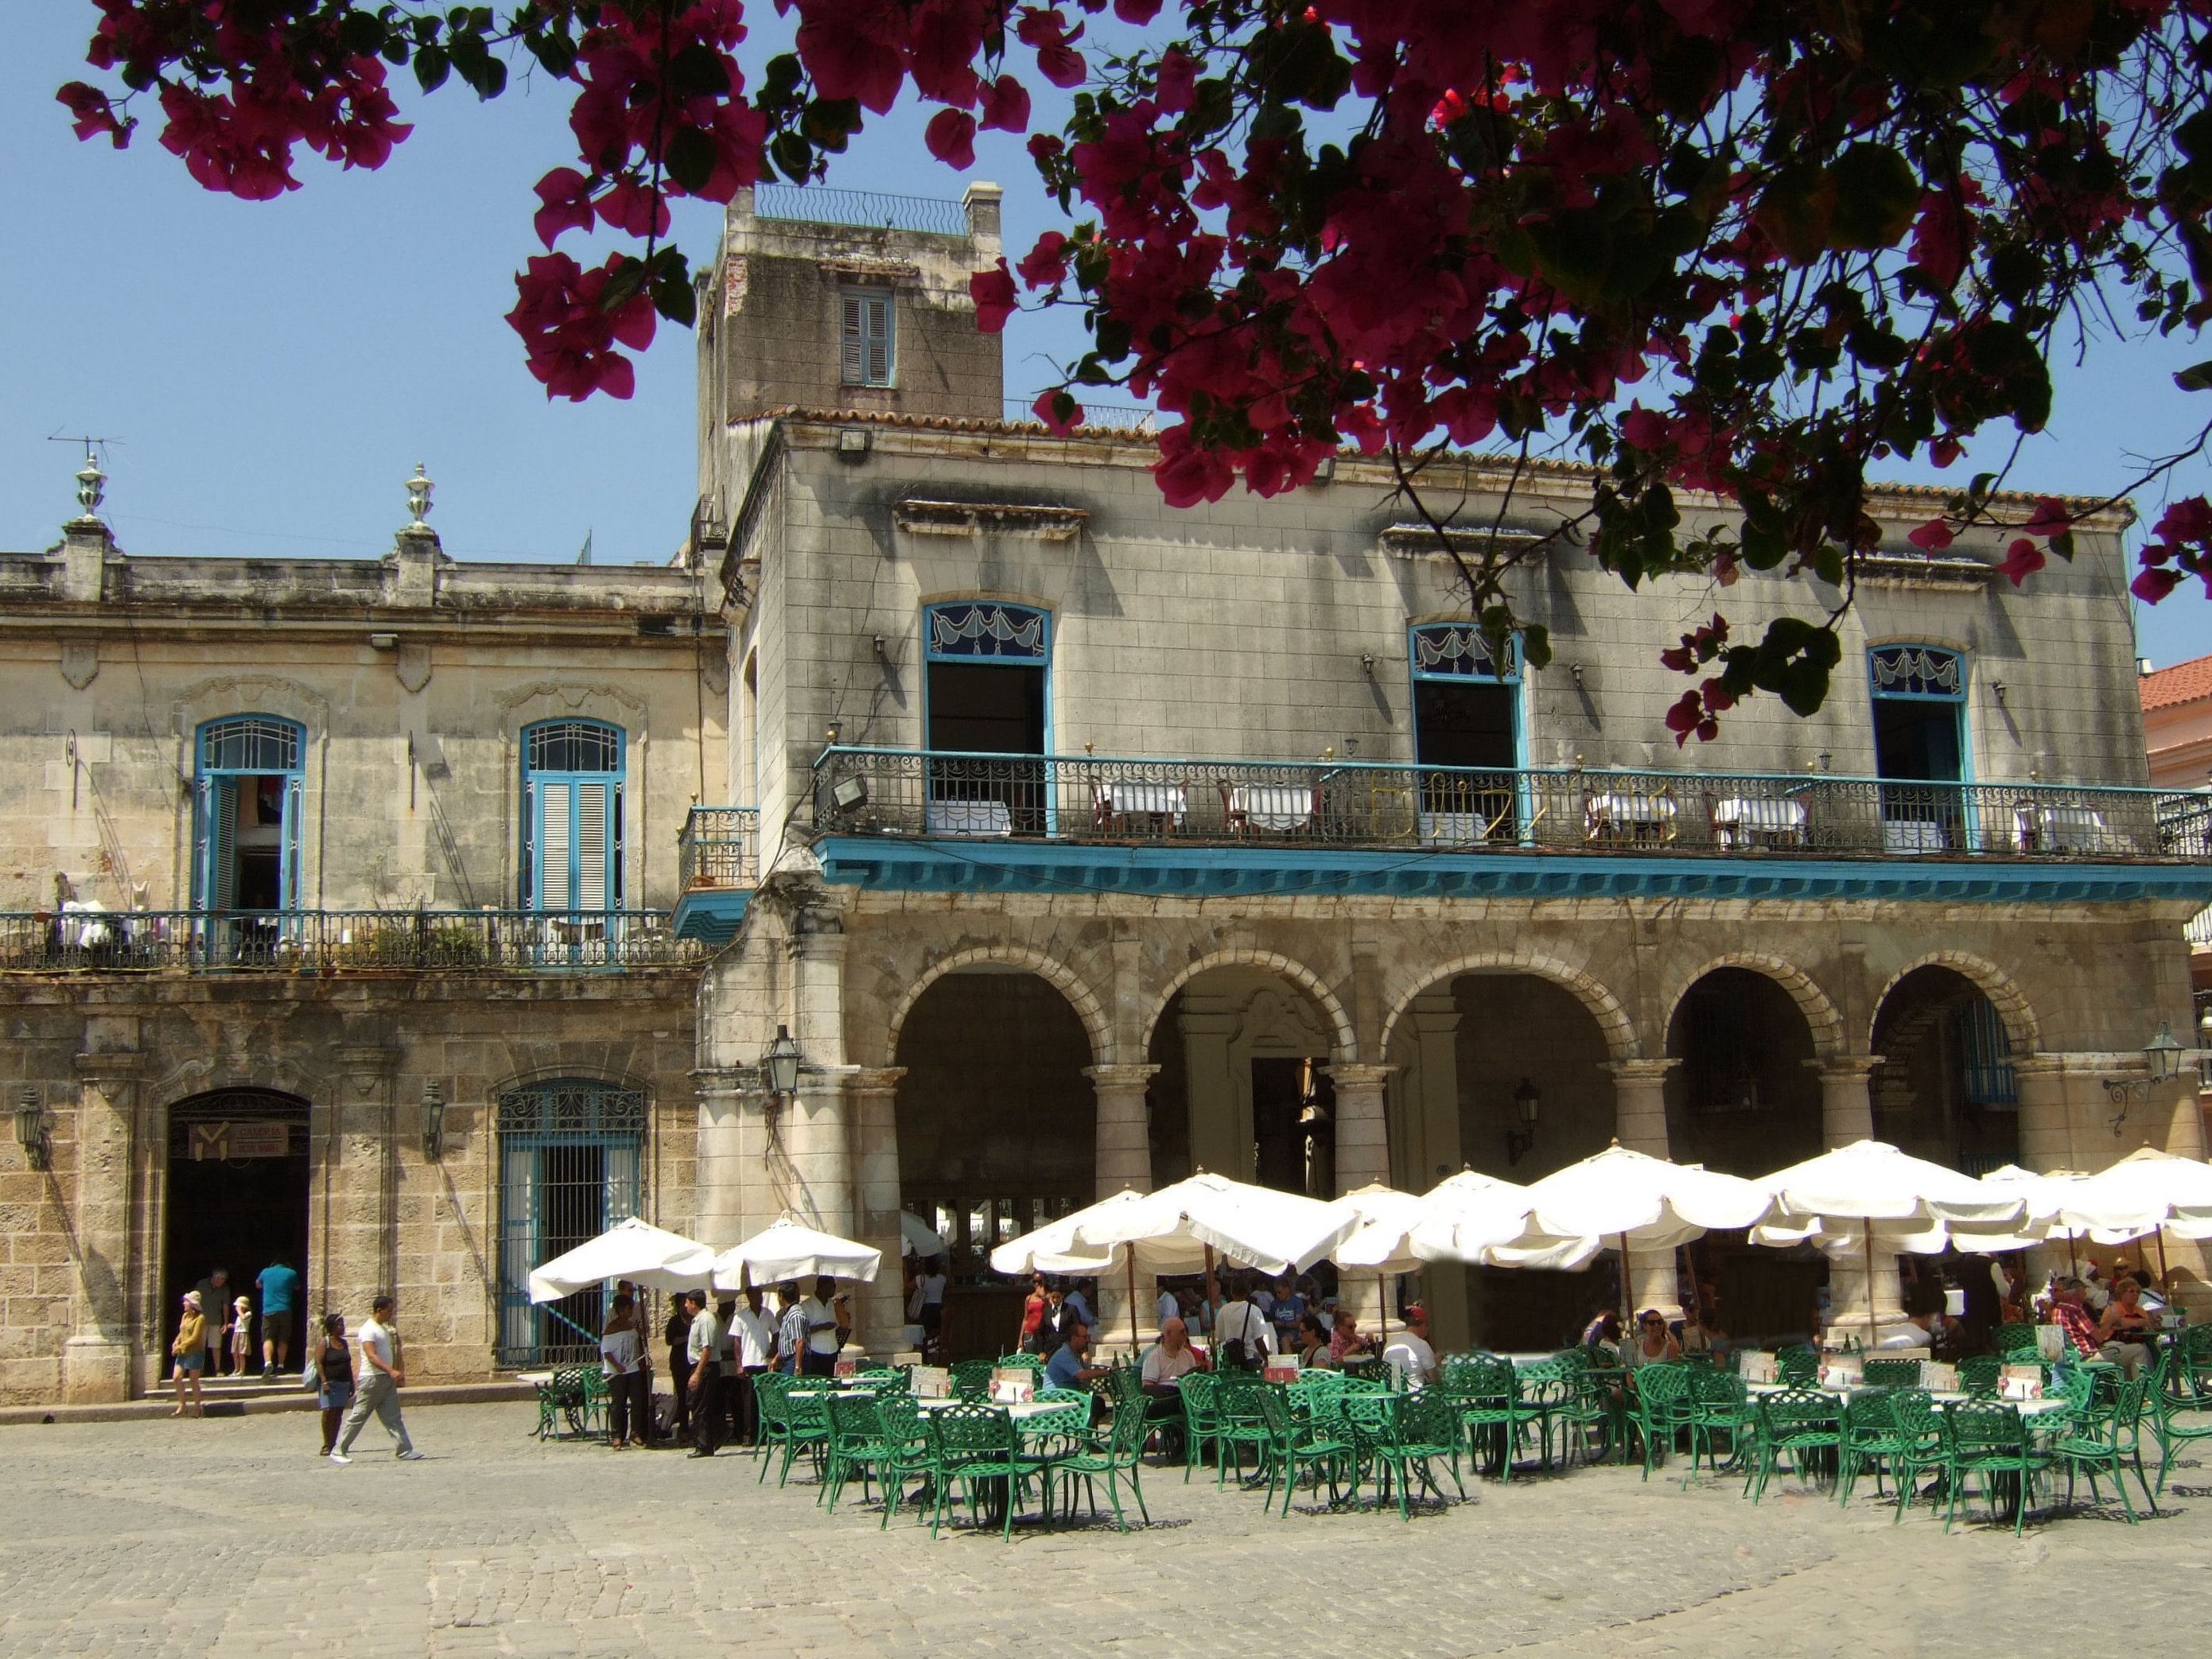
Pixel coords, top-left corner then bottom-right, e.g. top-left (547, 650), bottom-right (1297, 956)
top-left (0, 1405), bottom-right (2212, 1659)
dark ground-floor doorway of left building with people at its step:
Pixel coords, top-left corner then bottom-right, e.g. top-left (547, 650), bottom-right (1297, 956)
top-left (159, 1088), bottom-right (314, 1370)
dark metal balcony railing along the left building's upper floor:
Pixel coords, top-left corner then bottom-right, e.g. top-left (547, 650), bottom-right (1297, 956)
top-left (0, 905), bottom-right (703, 973)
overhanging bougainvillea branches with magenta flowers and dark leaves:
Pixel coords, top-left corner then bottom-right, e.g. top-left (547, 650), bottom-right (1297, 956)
top-left (60, 0), bottom-right (2212, 741)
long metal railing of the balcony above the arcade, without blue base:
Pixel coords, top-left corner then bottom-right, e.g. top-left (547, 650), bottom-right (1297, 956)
top-left (814, 748), bottom-right (2212, 863)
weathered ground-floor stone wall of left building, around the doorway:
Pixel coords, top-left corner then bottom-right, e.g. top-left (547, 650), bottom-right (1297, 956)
top-left (0, 971), bottom-right (699, 1402)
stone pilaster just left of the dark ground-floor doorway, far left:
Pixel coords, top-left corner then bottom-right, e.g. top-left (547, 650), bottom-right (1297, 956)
top-left (62, 1052), bottom-right (142, 1405)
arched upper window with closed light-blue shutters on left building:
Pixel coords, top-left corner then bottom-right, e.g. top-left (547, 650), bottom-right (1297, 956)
top-left (520, 721), bottom-right (624, 914)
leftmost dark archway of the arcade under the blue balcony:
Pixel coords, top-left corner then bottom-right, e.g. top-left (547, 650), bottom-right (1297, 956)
top-left (892, 956), bottom-right (1097, 1358)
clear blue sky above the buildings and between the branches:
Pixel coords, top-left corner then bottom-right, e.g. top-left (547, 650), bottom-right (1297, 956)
top-left (0, 0), bottom-right (2212, 666)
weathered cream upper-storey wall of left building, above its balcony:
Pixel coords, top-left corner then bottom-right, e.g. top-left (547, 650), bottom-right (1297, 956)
top-left (0, 526), bottom-right (728, 911)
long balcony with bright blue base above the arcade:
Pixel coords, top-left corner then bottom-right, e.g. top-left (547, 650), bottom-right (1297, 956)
top-left (756, 745), bottom-right (2212, 915)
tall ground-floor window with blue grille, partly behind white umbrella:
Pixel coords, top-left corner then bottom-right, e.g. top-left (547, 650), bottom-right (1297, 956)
top-left (496, 1078), bottom-right (646, 1365)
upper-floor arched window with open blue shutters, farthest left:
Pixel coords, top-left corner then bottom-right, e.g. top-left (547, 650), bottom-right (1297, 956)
top-left (192, 714), bottom-right (308, 911)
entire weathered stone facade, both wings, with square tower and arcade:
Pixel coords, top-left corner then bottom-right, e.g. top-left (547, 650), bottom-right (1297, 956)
top-left (0, 186), bottom-right (2212, 1401)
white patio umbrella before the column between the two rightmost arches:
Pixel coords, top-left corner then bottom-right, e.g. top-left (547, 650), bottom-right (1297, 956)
top-left (1752, 1141), bottom-right (2028, 1347)
